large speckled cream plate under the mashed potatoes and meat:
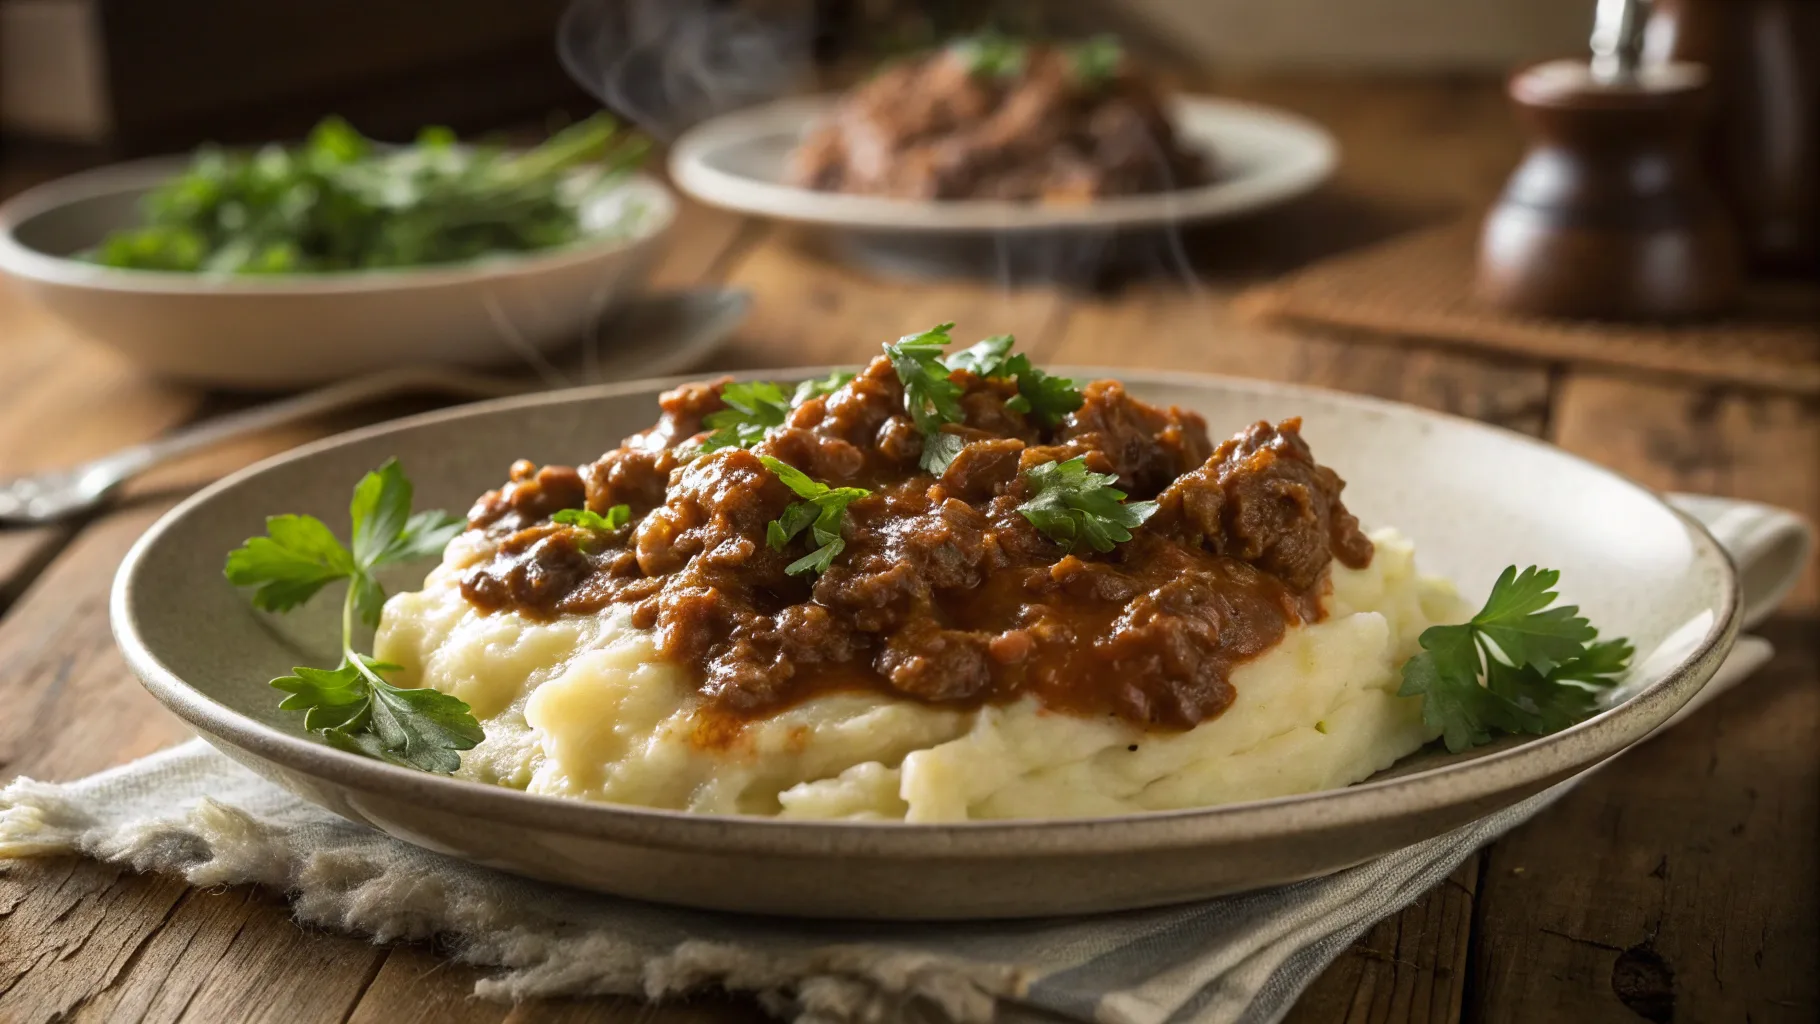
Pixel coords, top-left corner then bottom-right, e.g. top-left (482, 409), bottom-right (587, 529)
top-left (113, 371), bottom-right (1738, 919)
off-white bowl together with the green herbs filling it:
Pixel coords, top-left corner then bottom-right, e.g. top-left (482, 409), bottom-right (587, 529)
top-left (0, 116), bottom-right (675, 389)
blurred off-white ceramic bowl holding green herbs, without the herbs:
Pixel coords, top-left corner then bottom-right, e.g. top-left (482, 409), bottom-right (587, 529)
top-left (0, 158), bottom-right (675, 387)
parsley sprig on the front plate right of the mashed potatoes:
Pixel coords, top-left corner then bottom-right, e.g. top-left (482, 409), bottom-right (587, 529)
top-left (1398, 566), bottom-right (1634, 753)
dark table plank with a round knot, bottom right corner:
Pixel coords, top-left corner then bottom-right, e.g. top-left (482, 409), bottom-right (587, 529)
top-left (1471, 617), bottom-right (1820, 1024)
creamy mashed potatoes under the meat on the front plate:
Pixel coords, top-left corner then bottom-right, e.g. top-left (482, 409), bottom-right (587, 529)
top-left (375, 531), bottom-right (1471, 822)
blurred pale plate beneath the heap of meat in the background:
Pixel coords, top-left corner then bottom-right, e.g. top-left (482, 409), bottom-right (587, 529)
top-left (670, 96), bottom-right (1336, 233)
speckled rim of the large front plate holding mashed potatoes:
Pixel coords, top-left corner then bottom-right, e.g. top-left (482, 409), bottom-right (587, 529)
top-left (109, 367), bottom-right (1742, 858)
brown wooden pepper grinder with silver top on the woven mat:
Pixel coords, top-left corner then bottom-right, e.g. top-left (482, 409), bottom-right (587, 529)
top-left (1476, 0), bottom-right (1742, 320)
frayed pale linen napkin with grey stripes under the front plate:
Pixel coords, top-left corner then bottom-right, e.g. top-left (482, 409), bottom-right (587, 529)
top-left (0, 497), bottom-right (1813, 1024)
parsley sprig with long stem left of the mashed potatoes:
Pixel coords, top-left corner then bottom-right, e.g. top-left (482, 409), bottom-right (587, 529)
top-left (226, 458), bottom-right (482, 773)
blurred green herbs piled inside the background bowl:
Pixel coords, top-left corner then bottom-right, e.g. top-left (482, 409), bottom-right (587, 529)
top-left (84, 115), bottom-right (650, 275)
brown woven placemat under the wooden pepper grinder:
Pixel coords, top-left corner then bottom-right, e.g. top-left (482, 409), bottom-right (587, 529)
top-left (1236, 220), bottom-right (1820, 395)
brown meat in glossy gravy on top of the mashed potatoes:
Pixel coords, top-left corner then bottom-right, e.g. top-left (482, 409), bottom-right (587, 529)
top-left (462, 358), bottom-right (1372, 729)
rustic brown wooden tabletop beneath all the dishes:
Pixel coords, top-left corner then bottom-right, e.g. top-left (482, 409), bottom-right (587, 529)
top-left (0, 80), bottom-right (1820, 1024)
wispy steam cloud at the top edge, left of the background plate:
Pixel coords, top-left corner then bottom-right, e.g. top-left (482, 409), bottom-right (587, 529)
top-left (557, 0), bottom-right (810, 140)
